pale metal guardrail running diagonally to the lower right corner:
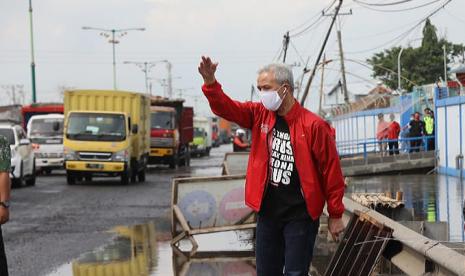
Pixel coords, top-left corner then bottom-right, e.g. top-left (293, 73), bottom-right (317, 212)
top-left (325, 198), bottom-right (465, 276)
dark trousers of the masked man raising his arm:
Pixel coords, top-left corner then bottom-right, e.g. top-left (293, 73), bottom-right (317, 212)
top-left (255, 215), bottom-right (320, 276)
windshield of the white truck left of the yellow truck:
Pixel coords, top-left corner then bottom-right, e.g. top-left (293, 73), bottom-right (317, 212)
top-left (29, 118), bottom-right (63, 144)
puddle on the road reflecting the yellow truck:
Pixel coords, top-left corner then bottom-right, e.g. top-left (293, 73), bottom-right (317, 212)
top-left (48, 223), bottom-right (256, 276)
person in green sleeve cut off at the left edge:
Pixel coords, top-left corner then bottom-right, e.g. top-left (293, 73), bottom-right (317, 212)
top-left (0, 136), bottom-right (11, 276)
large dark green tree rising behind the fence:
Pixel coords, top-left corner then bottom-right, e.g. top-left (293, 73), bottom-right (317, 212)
top-left (367, 19), bottom-right (465, 91)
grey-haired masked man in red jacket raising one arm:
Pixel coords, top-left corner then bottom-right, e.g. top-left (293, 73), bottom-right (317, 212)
top-left (199, 57), bottom-right (344, 276)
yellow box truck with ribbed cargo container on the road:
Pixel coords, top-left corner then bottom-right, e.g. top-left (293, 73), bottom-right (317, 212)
top-left (63, 90), bottom-right (150, 185)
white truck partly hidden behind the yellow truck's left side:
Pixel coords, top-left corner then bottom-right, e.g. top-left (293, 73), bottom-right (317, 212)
top-left (27, 114), bottom-right (64, 174)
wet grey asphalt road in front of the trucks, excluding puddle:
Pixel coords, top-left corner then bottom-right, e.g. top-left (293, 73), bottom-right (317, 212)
top-left (2, 145), bottom-right (232, 276)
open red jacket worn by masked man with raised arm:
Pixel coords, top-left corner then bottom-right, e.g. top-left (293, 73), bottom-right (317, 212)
top-left (202, 82), bottom-right (344, 219)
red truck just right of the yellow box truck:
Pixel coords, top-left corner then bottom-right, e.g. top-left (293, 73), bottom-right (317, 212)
top-left (149, 97), bottom-right (194, 168)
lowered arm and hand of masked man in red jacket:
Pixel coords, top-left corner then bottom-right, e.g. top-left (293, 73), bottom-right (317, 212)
top-left (312, 121), bottom-right (345, 236)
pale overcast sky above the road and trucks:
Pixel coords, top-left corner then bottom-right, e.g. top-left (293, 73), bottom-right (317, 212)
top-left (0, 0), bottom-right (465, 114)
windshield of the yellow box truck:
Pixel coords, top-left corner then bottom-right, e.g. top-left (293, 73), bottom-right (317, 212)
top-left (66, 113), bottom-right (126, 141)
